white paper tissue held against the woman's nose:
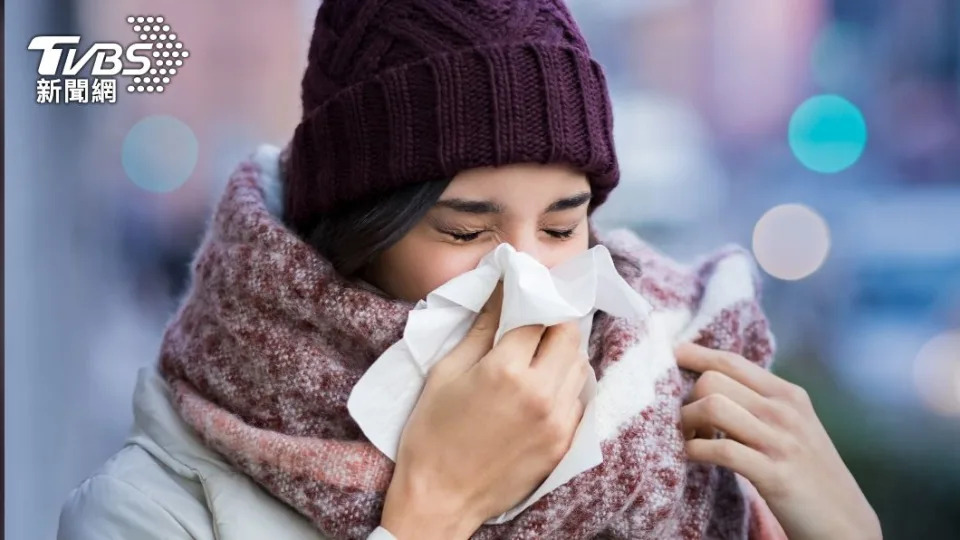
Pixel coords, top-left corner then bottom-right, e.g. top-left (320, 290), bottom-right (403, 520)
top-left (347, 243), bottom-right (652, 524)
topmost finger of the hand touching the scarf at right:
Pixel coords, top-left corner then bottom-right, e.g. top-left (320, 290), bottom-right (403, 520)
top-left (674, 343), bottom-right (790, 397)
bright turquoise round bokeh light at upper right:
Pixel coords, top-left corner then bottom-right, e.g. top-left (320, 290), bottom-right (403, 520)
top-left (788, 94), bottom-right (867, 173)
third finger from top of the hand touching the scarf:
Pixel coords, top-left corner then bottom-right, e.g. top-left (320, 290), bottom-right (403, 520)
top-left (680, 394), bottom-right (777, 453)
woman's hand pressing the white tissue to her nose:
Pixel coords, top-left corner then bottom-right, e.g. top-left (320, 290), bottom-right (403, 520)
top-left (381, 286), bottom-right (590, 540)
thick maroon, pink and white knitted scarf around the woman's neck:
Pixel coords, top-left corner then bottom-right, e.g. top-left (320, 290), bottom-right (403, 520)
top-left (159, 153), bottom-right (774, 540)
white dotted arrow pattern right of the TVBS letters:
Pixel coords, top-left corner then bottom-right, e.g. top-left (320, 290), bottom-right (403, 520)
top-left (127, 15), bottom-right (190, 93)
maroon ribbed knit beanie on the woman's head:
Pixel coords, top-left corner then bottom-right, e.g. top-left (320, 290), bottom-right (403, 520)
top-left (284, 0), bottom-right (619, 234)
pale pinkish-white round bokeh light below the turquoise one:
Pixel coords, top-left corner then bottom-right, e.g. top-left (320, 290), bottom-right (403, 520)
top-left (753, 204), bottom-right (830, 280)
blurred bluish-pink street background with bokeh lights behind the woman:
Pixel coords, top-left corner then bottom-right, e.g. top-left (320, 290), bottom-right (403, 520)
top-left (4, 0), bottom-right (960, 539)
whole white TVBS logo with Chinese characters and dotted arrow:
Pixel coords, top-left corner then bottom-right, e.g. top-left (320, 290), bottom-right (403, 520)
top-left (27, 16), bottom-right (190, 103)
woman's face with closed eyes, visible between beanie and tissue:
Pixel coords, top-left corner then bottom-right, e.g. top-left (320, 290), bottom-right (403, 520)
top-left (366, 164), bottom-right (590, 302)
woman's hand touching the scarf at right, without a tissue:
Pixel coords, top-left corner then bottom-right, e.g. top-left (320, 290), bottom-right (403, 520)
top-left (676, 343), bottom-right (882, 540)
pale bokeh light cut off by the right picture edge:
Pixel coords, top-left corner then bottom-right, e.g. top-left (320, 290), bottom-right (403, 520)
top-left (913, 330), bottom-right (960, 416)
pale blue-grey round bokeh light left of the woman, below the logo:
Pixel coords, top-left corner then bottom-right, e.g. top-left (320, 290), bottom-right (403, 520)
top-left (121, 115), bottom-right (199, 193)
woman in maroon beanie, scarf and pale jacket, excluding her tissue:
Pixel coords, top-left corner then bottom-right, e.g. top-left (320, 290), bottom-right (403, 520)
top-left (60, 0), bottom-right (880, 540)
